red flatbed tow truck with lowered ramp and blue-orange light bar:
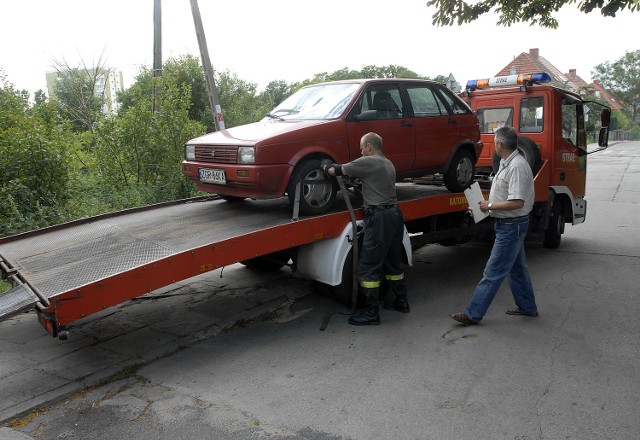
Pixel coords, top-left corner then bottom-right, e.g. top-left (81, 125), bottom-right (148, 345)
top-left (0, 74), bottom-right (610, 339)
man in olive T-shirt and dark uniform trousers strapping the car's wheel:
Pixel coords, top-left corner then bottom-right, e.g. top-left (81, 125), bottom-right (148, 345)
top-left (322, 133), bottom-right (409, 325)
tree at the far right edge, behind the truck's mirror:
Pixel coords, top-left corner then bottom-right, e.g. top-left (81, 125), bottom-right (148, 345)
top-left (592, 50), bottom-right (640, 123)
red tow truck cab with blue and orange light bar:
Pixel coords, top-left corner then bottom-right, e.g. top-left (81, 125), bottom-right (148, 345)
top-left (463, 72), bottom-right (610, 248)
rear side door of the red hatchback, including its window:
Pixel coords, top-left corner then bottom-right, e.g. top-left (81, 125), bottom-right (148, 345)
top-left (406, 83), bottom-right (460, 170)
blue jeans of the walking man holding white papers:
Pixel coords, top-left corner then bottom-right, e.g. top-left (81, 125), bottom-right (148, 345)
top-left (464, 216), bottom-right (538, 322)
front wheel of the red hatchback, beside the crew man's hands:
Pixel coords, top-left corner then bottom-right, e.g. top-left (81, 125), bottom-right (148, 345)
top-left (287, 159), bottom-right (338, 215)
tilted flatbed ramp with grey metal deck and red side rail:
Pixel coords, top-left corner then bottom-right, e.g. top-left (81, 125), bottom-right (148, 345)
top-left (0, 184), bottom-right (465, 336)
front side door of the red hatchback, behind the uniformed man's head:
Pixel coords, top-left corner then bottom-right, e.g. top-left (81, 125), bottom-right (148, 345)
top-left (346, 82), bottom-right (415, 173)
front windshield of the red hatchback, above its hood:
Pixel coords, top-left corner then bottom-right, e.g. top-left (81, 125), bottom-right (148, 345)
top-left (267, 83), bottom-right (360, 120)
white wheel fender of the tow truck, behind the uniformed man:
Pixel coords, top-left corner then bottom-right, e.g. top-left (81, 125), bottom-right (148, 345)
top-left (296, 220), bottom-right (412, 286)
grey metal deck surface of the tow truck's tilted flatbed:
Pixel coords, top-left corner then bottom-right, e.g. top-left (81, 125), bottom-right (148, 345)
top-left (0, 184), bottom-right (448, 320)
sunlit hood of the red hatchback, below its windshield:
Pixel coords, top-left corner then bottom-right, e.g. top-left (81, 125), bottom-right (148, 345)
top-left (187, 120), bottom-right (331, 146)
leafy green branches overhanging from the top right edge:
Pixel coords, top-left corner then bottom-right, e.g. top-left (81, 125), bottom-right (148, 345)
top-left (427, 0), bottom-right (640, 29)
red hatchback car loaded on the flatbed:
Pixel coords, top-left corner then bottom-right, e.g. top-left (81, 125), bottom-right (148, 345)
top-left (182, 79), bottom-right (482, 214)
